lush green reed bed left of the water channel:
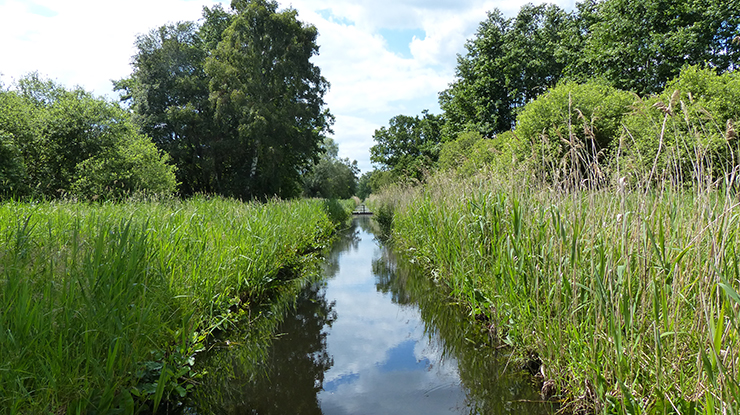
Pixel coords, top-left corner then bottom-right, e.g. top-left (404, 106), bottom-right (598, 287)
top-left (0, 199), bottom-right (334, 414)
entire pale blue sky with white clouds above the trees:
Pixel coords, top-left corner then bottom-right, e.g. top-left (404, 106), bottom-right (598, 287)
top-left (0, 0), bottom-right (574, 172)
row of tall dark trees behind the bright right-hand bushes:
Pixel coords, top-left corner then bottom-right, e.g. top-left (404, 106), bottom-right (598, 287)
top-left (440, 0), bottom-right (740, 138)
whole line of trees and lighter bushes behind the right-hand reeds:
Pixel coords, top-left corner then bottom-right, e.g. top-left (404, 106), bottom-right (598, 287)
top-left (359, 0), bottom-right (740, 197)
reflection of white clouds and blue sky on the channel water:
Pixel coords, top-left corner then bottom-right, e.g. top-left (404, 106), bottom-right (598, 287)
top-left (318, 233), bottom-right (466, 414)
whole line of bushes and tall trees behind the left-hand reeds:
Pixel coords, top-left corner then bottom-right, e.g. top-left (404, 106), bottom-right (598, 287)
top-left (0, 0), bottom-right (359, 200)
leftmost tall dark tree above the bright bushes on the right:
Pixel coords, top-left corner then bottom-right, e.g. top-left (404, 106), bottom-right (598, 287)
top-left (440, 4), bottom-right (576, 138)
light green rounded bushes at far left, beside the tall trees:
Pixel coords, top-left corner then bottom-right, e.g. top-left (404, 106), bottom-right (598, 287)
top-left (0, 74), bottom-right (176, 199)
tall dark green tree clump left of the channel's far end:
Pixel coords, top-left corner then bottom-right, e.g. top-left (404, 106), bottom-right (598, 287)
top-left (117, 0), bottom-right (333, 199)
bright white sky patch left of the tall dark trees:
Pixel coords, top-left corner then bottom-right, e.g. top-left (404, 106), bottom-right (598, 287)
top-left (0, 0), bottom-right (223, 97)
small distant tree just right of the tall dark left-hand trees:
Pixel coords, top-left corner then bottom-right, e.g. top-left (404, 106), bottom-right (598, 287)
top-left (303, 137), bottom-right (360, 199)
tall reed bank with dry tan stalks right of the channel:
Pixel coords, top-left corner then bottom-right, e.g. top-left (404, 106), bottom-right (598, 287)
top-left (373, 175), bottom-right (740, 414)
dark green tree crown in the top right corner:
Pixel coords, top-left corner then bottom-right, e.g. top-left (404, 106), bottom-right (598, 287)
top-left (579, 0), bottom-right (740, 95)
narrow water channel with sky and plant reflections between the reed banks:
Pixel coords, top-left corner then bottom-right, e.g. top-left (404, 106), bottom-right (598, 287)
top-left (186, 217), bottom-right (553, 415)
